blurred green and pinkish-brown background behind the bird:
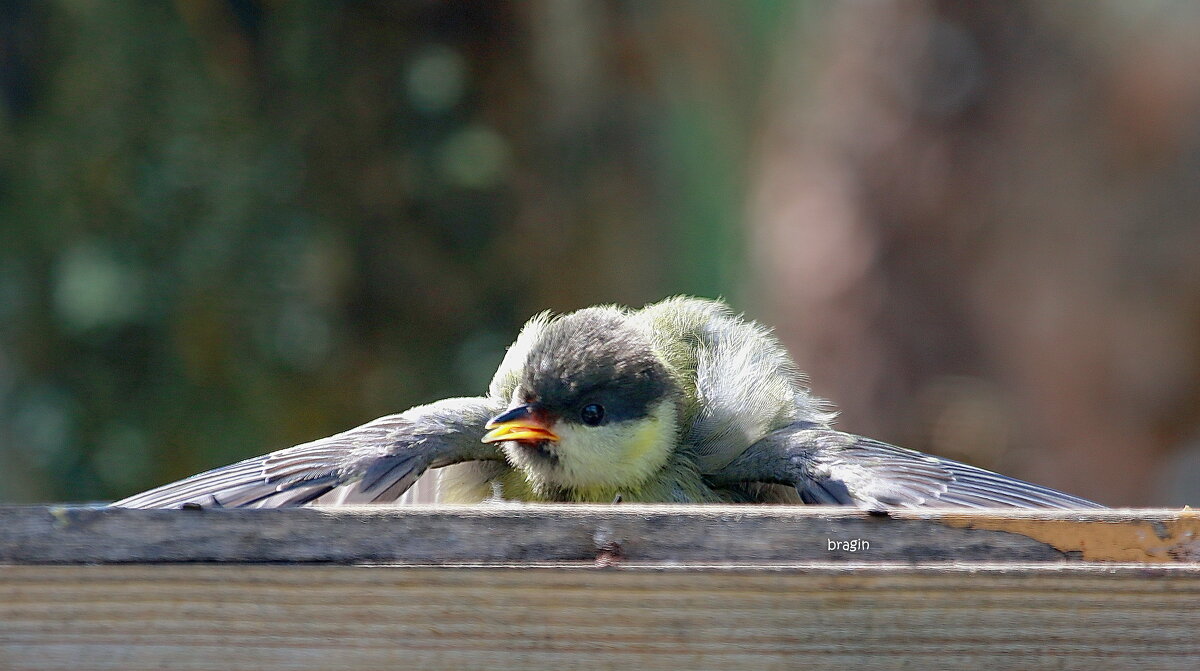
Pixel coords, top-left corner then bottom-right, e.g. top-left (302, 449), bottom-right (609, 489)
top-left (0, 0), bottom-right (1200, 504)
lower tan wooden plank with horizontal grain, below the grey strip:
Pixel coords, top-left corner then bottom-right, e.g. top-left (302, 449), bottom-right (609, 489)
top-left (0, 563), bottom-right (1200, 671)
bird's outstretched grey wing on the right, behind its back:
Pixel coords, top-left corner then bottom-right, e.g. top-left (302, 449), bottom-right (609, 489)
top-left (712, 423), bottom-right (1103, 509)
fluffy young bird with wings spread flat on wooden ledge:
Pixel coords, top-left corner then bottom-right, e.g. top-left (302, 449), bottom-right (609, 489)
top-left (110, 296), bottom-right (1103, 511)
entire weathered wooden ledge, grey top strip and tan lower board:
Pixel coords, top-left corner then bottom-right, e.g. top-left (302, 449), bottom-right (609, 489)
top-left (0, 505), bottom-right (1200, 671)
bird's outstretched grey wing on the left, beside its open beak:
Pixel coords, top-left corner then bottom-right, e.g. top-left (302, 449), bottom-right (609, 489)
top-left (113, 397), bottom-right (504, 508)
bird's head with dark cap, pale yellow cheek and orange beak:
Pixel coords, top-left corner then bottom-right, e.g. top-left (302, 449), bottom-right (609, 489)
top-left (484, 308), bottom-right (678, 501)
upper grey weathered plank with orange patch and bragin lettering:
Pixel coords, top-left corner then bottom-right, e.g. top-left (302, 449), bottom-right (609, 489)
top-left (0, 505), bottom-right (1200, 564)
